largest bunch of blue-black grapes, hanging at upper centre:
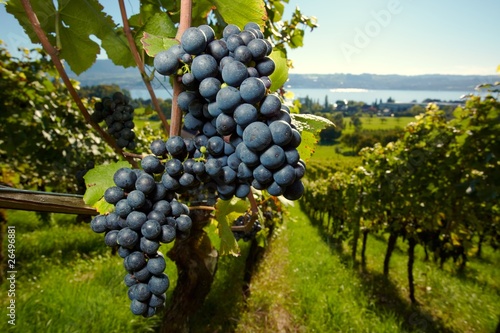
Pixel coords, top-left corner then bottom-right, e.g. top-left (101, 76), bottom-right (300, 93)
top-left (154, 23), bottom-right (305, 200)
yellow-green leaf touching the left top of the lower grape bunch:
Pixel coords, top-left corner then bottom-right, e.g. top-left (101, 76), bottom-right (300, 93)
top-left (83, 161), bottom-right (131, 214)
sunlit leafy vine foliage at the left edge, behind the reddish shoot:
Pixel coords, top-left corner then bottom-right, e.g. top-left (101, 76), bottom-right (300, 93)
top-left (0, 44), bottom-right (113, 192)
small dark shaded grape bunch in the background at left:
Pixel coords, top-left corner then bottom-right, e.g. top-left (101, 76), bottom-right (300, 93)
top-left (91, 92), bottom-right (137, 150)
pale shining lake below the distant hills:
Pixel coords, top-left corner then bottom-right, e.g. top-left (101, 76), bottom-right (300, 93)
top-left (130, 88), bottom-right (475, 104)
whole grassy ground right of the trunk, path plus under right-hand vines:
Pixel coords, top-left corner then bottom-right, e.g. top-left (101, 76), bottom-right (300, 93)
top-left (237, 206), bottom-right (500, 333)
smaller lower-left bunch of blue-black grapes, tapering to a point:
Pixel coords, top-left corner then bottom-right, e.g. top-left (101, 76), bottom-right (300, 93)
top-left (90, 160), bottom-right (192, 317)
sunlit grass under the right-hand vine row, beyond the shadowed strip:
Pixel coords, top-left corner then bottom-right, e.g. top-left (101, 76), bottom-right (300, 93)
top-left (362, 231), bottom-right (500, 332)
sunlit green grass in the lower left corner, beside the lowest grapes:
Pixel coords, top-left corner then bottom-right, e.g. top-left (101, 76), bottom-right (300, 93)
top-left (0, 255), bottom-right (168, 333)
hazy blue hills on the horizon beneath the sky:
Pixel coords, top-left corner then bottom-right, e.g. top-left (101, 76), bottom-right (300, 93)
top-left (69, 59), bottom-right (500, 91)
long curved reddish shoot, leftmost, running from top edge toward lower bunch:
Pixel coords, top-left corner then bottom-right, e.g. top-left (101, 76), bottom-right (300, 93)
top-left (21, 0), bottom-right (138, 168)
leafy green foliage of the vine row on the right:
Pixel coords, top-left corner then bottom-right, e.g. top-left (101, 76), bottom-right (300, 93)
top-left (304, 96), bottom-right (500, 272)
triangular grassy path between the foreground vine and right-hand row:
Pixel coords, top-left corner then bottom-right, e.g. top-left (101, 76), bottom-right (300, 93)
top-left (237, 206), bottom-right (410, 332)
